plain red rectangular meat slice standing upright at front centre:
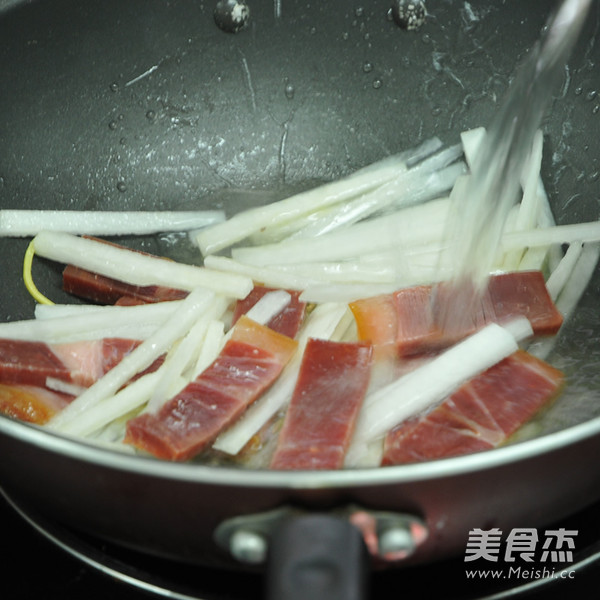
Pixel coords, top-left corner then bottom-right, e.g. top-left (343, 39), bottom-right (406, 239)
top-left (271, 339), bottom-right (372, 469)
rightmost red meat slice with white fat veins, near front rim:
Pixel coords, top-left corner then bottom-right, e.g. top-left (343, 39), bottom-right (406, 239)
top-left (382, 350), bottom-right (563, 465)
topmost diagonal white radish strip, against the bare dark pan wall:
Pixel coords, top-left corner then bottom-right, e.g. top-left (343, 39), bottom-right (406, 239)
top-left (195, 156), bottom-right (406, 255)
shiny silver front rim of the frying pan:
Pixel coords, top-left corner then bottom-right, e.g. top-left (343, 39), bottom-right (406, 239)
top-left (0, 416), bottom-right (600, 489)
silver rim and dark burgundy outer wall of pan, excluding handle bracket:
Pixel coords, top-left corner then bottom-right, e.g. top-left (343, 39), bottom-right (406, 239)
top-left (0, 410), bottom-right (600, 568)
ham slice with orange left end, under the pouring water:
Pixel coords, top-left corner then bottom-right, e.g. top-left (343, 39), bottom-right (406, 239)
top-left (350, 271), bottom-right (563, 357)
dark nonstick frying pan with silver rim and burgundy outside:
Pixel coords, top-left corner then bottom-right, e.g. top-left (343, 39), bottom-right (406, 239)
top-left (0, 0), bottom-right (600, 598)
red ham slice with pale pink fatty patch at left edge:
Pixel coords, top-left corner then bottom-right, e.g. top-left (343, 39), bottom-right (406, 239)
top-left (0, 338), bottom-right (152, 387)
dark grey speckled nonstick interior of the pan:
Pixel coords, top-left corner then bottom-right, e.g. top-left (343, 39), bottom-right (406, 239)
top-left (0, 0), bottom-right (600, 435)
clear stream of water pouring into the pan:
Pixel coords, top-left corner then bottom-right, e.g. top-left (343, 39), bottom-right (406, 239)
top-left (433, 0), bottom-right (591, 331)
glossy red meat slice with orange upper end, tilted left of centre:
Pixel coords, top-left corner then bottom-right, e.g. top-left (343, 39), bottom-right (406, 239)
top-left (125, 316), bottom-right (297, 461)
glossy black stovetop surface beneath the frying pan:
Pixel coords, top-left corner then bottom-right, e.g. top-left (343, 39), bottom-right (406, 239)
top-left (0, 492), bottom-right (600, 600)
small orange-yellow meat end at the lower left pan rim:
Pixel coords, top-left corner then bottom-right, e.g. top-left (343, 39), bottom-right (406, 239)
top-left (0, 384), bottom-right (73, 425)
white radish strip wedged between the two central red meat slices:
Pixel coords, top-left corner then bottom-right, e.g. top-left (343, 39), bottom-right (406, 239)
top-left (213, 304), bottom-right (347, 455)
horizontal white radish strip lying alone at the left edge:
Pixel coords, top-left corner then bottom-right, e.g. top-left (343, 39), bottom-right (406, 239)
top-left (0, 209), bottom-right (225, 237)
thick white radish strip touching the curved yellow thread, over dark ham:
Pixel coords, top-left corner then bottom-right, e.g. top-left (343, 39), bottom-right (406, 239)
top-left (33, 232), bottom-right (253, 298)
